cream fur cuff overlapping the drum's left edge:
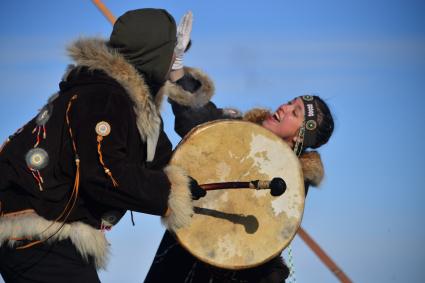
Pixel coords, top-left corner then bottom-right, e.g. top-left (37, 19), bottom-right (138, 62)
top-left (162, 165), bottom-right (193, 231)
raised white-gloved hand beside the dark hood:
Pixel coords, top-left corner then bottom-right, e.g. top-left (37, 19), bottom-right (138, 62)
top-left (171, 11), bottom-right (193, 70)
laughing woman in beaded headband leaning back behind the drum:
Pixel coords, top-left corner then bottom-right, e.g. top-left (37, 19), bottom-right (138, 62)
top-left (144, 12), bottom-right (334, 283)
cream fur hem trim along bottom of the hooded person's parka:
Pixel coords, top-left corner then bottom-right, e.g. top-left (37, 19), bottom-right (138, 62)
top-left (0, 212), bottom-right (109, 269)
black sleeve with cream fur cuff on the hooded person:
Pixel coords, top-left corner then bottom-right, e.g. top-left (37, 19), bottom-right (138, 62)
top-left (71, 91), bottom-right (192, 231)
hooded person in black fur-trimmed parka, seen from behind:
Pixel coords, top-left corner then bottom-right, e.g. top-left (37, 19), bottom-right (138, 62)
top-left (0, 9), bottom-right (207, 282)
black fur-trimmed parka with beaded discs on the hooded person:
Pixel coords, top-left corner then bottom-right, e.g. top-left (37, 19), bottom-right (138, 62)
top-left (0, 39), bottom-right (209, 268)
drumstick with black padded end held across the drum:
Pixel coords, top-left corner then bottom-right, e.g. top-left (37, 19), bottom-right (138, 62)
top-left (199, 178), bottom-right (286, 197)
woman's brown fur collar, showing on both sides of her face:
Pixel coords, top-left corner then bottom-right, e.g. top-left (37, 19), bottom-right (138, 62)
top-left (243, 108), bottom-right (324, 186)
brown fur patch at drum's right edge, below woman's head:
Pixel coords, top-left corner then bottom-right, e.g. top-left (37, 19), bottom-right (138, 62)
top-left (300, 151), bottom-right (324, 187)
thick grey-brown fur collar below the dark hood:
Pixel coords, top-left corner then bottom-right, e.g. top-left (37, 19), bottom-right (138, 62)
top-left (68, 38), bottom-right (162, 155)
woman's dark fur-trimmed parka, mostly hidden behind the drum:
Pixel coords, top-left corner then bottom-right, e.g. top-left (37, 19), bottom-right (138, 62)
top-left (145, 68), bottom-right (323, 283)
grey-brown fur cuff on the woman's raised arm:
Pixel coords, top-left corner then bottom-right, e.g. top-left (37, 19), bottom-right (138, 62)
top-left (160, 67), bottom-right (214, 108)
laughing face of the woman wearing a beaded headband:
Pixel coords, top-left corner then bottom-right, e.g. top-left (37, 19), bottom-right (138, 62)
top-left (263, 97), bottom-right (304, 145)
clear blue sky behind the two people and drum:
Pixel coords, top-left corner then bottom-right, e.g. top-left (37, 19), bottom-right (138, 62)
top-left (0, 0), bottom-right (425, 283)
